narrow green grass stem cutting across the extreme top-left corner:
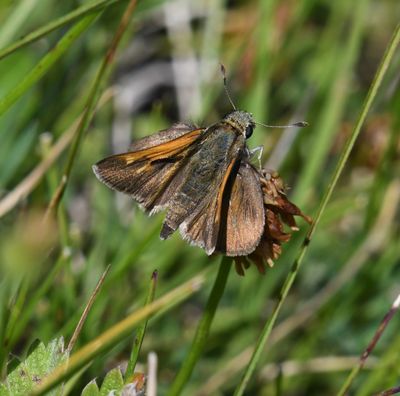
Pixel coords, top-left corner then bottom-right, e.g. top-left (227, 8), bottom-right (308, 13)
top-left (0, 0), bottom-right (122, 60)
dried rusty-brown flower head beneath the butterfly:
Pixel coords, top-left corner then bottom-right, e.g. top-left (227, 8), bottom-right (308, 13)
top-left (235, 169), bottom-right (311, 275)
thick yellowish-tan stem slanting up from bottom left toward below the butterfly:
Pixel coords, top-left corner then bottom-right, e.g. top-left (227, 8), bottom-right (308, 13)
top-left (31, 273), bottom-right (205, 395)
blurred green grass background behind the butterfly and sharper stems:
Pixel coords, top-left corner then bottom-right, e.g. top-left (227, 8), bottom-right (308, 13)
top-left (0, 0), bottom-right (400, 395)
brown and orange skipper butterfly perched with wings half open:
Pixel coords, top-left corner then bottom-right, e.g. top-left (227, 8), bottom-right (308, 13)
top-left (93, 110), bottom-right (265, 256)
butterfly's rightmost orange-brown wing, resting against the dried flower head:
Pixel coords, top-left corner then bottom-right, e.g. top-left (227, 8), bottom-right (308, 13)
top-left (216, 161), bottom-right (265, 256)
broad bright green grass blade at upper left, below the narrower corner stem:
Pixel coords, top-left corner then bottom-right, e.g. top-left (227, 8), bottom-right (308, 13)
top-left (0, 14), bottom-right (98, 116)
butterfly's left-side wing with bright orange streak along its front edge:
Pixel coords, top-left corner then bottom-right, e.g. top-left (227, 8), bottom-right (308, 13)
top-left (93, 124), bottom-right (203, 211)
